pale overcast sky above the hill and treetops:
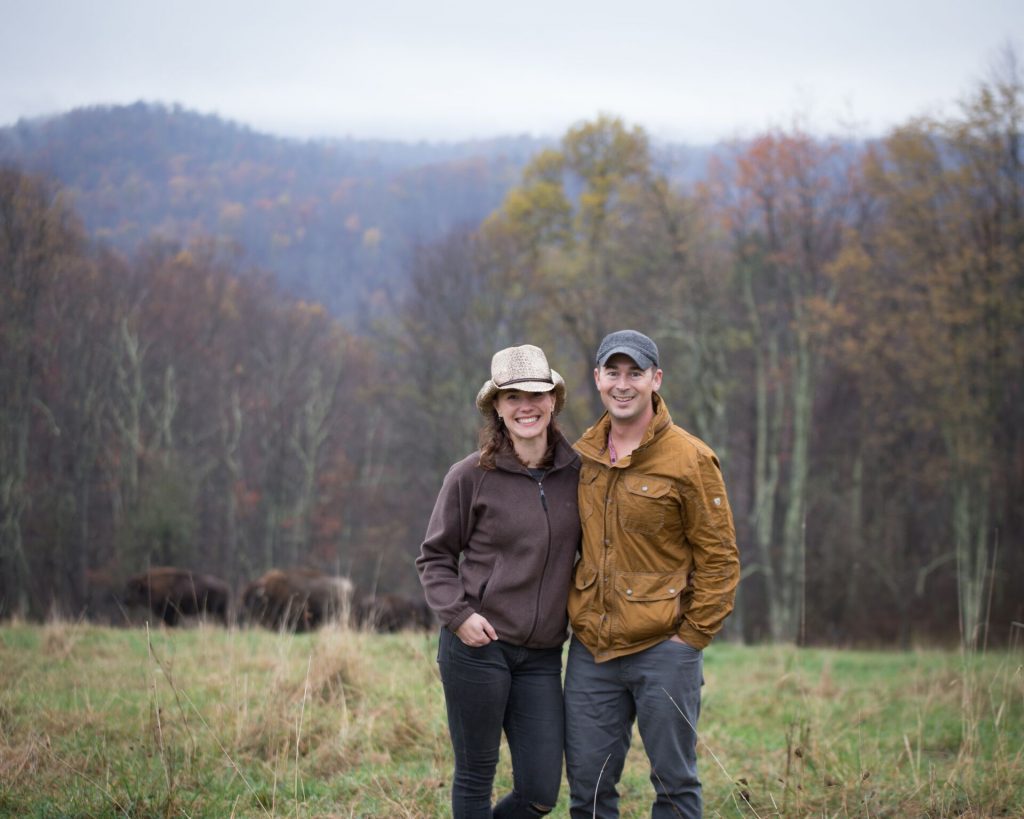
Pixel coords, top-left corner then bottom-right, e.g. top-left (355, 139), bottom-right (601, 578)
top-left (0, 0), bottom-right (1024, 143)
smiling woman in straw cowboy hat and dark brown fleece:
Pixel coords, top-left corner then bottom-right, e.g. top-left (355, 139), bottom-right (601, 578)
top-left (416, 344), bottom-right (580, 819)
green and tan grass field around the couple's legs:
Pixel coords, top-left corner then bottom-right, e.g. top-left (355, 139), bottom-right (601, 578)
top-left (0, 622), bottom-right (1024, 817)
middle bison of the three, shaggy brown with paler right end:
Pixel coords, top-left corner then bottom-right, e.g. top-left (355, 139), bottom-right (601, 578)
top-left (242, 569), bottom-right (352, 632)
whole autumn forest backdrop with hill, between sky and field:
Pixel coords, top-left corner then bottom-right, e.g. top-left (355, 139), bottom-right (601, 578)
top-left (0, 59), bottom-right (1024, 646)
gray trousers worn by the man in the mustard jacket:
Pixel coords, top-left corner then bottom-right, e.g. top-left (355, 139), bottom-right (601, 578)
top-left (565, 637), bottom-right (703, 819)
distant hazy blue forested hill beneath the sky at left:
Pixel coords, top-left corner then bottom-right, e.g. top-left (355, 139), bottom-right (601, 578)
top-left (0, 102), bottom-right (545, 317)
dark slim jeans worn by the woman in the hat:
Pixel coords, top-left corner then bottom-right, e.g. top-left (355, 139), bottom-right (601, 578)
top-left (437, 629), bottom-right (563, 819)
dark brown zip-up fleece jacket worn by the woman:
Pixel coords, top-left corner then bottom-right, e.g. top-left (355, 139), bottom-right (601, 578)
top-left (416, 435), bottom-right (580, 648)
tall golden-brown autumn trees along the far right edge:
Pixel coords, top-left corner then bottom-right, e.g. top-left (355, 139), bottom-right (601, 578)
top-left (837, 59), bottom-right (1024, 644)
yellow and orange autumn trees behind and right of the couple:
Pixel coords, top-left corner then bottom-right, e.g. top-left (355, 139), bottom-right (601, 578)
top-left (387, 94), bottom-right (1024, 645)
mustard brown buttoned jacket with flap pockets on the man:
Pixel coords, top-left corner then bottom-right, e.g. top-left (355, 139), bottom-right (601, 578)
top-left (568, 393), bottom-right (739, 662)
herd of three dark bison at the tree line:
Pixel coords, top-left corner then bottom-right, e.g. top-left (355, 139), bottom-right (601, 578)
top-left (122, 566), bottom-right (433, 632)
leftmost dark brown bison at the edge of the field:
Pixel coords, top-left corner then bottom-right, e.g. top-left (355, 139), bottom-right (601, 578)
top-left (124, 566), bottom-right (231, 626)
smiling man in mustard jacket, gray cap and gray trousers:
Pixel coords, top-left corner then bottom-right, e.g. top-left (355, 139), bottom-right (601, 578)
top-left (565, 330), bottom-right (739, 819)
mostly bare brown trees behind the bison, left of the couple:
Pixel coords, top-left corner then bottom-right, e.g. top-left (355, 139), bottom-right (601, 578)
top-left (0, 176), bottom-right (387, 615)
